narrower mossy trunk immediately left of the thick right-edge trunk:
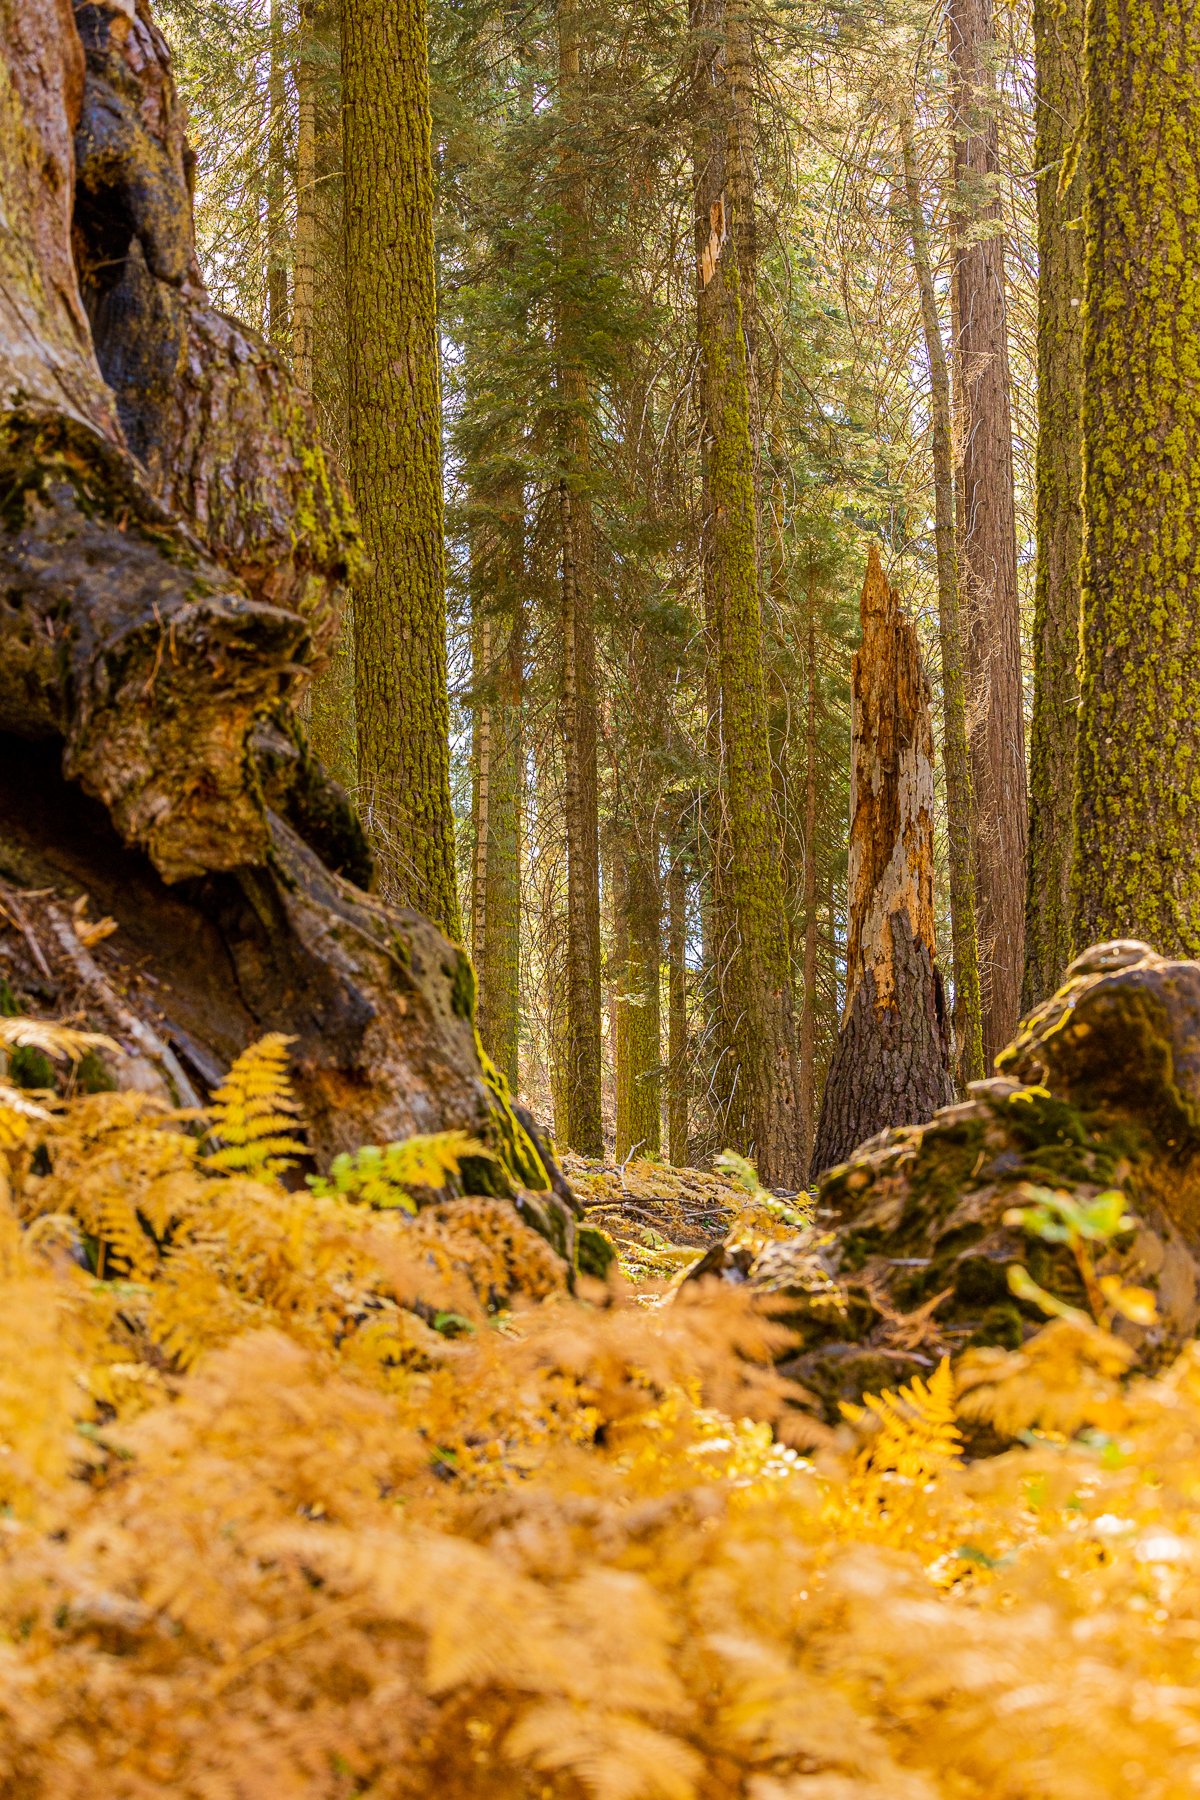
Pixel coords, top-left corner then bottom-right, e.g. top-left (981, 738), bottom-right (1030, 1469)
top-left (1022, 0), bottom-right (1087, 1012)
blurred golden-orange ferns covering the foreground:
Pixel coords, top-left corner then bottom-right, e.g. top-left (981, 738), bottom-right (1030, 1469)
top-left (0, 1021), bottom-right (1200, 1800)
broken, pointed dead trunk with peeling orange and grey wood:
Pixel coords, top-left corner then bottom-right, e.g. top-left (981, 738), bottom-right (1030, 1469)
top-left (810, 545), bottom-right (954, 1179)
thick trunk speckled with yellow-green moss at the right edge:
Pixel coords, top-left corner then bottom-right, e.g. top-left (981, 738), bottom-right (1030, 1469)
top-left (1072, 0), bottom-right (1200, 956)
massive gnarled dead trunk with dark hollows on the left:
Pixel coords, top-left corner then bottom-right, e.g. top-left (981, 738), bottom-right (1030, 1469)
top-left (0, 0), bottom-right (572, 1249)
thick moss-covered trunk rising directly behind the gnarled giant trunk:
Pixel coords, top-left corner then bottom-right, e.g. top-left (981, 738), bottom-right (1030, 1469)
top-left (342, 0), bottom-right (459, 938)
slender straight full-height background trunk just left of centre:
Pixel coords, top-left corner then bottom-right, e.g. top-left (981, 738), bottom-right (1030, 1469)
top-left (558, 0), bottom-right (604, 1156)
